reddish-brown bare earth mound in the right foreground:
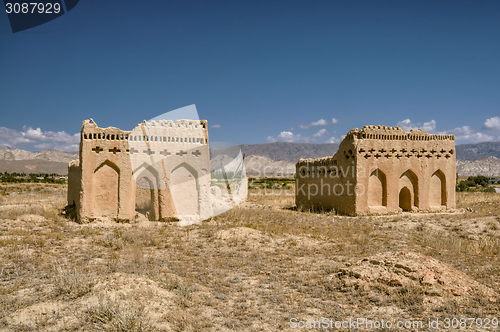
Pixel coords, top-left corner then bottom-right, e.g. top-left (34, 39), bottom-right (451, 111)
top-left (340, 251), bottom-right (498, 301)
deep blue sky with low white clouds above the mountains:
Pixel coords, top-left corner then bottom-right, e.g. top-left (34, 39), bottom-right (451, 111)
top-left (0, 0), bottom-right (500, 151)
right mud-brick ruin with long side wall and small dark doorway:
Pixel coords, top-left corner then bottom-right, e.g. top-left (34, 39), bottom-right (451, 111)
top-left (296, 126), bottom-right (456, 215)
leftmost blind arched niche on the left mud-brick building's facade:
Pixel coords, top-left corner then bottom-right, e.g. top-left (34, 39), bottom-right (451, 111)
top-left (93, 160), bottom-right (120, 217)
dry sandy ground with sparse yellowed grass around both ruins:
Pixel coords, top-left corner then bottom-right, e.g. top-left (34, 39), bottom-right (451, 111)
top-left (0, 184), bottom-right (500, 331)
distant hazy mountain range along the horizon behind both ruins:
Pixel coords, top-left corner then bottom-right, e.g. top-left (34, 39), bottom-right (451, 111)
top-left (0, 142), bottom-right (500, 176)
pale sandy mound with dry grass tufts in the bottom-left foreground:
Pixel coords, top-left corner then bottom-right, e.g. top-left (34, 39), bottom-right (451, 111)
top-left (5, 273), bottom-right (217, 331)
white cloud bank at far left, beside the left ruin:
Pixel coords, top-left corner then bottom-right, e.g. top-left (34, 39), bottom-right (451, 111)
top-left (0, 126), bottom-right (80, 152)
